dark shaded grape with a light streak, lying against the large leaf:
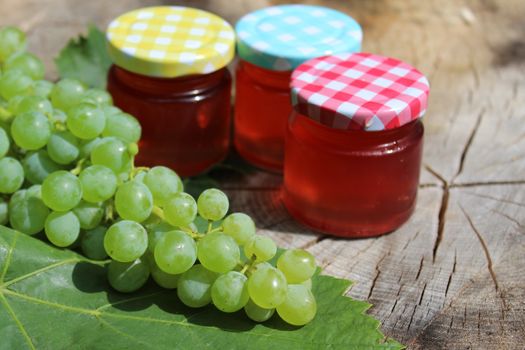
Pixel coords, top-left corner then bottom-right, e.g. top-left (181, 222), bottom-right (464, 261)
top-left (108, 258), bottom-right (150, 293)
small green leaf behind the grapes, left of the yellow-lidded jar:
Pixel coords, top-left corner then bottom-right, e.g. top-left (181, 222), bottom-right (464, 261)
top-left (55, 26), bottom-right (111, 89)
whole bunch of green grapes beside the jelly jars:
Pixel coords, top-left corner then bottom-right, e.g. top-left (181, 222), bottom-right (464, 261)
top-left (0, 27), bottom-right (317, 325)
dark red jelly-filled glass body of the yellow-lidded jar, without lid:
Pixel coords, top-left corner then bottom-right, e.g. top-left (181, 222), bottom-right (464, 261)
top-left (108, 66), bottom-right (231, 176)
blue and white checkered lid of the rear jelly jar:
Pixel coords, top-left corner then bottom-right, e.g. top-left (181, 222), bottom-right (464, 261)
top-left (235, 5), bottom-right (363, 71)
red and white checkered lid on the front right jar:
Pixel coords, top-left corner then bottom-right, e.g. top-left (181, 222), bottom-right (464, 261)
top-left (291, 53), bottom-right (429, 131)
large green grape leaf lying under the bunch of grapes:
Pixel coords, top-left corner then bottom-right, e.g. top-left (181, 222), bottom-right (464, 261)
top-left (0, 226), bottom-right (402, 350)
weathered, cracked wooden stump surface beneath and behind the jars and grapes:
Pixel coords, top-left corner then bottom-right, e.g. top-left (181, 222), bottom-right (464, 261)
top-left (0, 0), bottom-right (525, 349)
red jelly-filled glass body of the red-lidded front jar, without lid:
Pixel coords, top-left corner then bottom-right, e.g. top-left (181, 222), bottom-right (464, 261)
top-left (283, 115), bottom-right (423, 237)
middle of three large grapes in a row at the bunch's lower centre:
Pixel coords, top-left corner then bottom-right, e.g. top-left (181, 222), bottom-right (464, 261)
top-left (154, 231), bottom-right (197, 275)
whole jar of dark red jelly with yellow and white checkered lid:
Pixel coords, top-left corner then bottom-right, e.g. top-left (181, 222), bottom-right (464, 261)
top-left (107, 6), bottom-right (235, 176)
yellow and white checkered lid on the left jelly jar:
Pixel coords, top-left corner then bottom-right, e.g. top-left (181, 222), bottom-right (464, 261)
top-left (106, 6), bottom-right (235, 78)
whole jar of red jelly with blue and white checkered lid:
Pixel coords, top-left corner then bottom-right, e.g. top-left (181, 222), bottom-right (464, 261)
top-left (234, 5), bottom-right (362, 172)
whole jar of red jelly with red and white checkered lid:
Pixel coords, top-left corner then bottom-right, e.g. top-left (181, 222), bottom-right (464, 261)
top-left (283, 53), bottom-right (429, 237)
